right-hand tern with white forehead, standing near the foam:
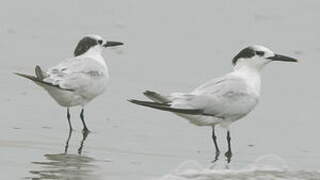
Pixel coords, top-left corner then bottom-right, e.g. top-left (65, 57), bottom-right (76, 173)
top-left (129, 45), bottom-right (298, 163)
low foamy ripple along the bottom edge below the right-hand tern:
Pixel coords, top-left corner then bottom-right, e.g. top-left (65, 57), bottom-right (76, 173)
top-left (158, 156), bottom-right (320, 180)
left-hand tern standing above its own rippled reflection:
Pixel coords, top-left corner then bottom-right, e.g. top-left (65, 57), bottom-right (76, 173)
top-left (15, 35), bottom-right (123, 132)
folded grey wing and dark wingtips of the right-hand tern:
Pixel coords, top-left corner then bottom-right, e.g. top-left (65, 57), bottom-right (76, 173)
top-left (131, 76), bottom-right (258, 118)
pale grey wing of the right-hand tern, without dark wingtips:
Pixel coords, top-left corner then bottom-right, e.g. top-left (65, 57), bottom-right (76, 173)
top-left (172, 76), bottom-right (258, 118)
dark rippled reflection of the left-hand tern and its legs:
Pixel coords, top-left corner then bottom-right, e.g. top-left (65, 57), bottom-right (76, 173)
top-left (30, 131), bottom-right (99, 180)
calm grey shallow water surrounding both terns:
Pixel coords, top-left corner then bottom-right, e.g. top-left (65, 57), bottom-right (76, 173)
top-left (0, 0), bottom-right (320, 180)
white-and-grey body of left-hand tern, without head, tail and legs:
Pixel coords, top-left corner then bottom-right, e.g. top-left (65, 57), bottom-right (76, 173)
top-left (45, 54), bottom-right (109, 107)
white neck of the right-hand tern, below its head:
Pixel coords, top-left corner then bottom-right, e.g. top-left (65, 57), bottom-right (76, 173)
top-left (233, 66), bottom-right (261, 96)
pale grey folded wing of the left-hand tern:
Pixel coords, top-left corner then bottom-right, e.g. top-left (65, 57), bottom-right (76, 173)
top-left (44, 58), bottom-right (106, 90)
